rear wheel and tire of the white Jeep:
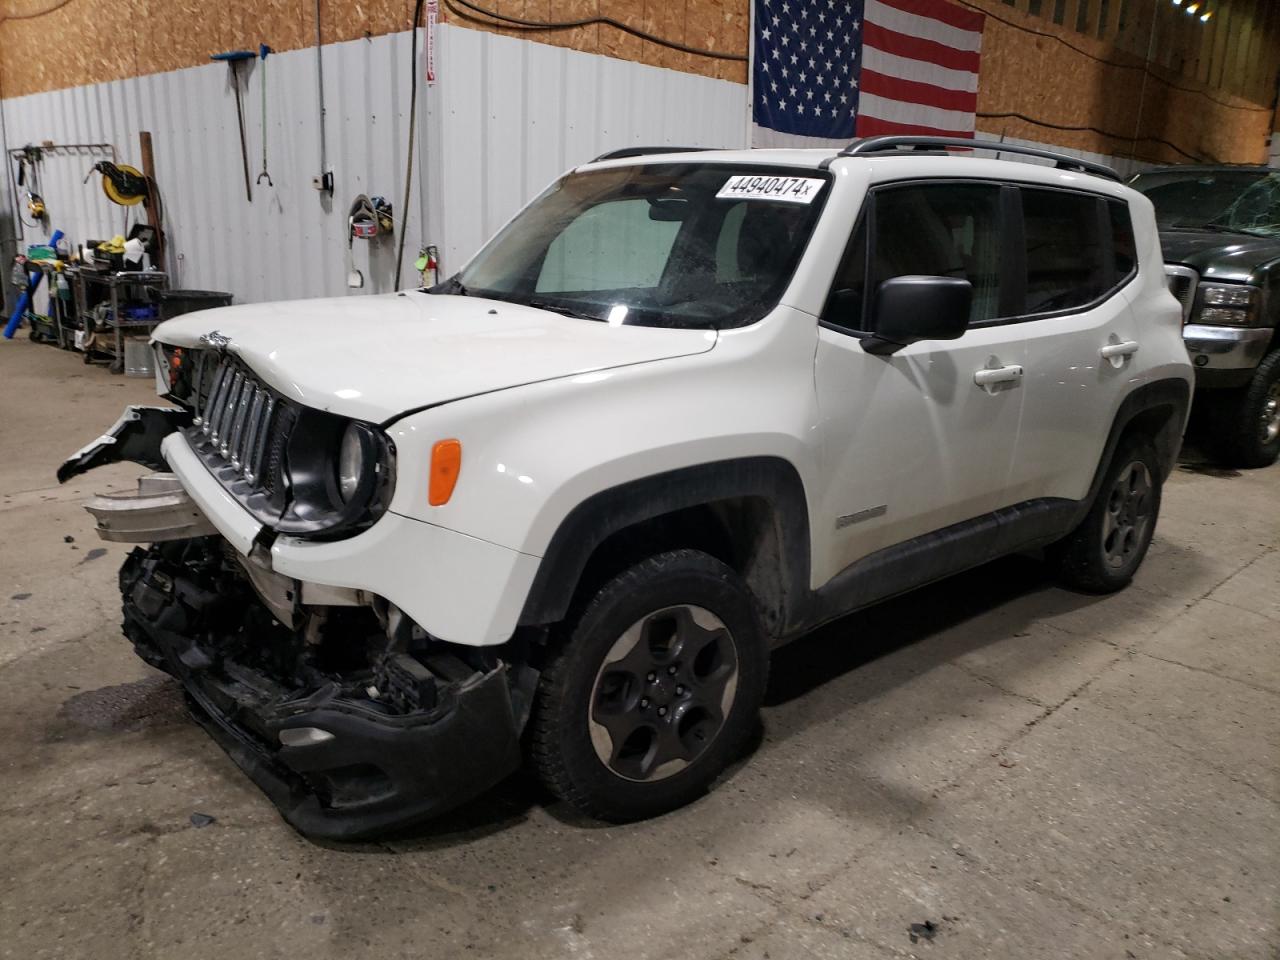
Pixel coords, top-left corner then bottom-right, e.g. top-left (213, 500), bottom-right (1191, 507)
top-left (1047, 438), bottom-right (1164, 594)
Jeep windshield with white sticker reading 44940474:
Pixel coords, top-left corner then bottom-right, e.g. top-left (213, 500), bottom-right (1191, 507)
top-left (448, 164), bottom-right (831, 329)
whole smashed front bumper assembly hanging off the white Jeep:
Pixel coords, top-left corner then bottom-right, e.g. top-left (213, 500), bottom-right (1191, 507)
top-left (58, 407), bottom-right (522, 840)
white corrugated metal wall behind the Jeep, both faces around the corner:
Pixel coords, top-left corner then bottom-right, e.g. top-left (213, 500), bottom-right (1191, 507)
top-left (4, 26), bottom-right (746, 312)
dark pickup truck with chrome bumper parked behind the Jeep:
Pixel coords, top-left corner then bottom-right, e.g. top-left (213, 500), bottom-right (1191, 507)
top-left (1130, 166), bottom-right (1280, 467)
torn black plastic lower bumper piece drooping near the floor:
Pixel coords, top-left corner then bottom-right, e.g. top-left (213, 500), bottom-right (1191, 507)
top-left (120, 550), bottom-right (520, 840)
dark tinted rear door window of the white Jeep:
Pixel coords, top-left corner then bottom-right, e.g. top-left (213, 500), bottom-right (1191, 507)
top-left (1023, 188), bottom-right (1112, 314)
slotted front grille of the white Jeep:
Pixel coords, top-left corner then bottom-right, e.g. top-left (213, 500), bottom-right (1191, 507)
top-left (192, 352), bottom-right (292, 488)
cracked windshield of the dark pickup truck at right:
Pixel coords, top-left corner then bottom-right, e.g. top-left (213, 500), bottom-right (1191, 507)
top-left (1130, 170), bottom-right (1280, 237)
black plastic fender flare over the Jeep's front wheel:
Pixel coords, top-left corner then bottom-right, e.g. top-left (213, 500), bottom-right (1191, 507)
top-left (520, 457), bottom-right (810, 640)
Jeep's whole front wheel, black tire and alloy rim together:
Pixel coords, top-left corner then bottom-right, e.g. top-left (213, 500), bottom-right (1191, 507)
top-left (529, 550), bottom-right (769, 822)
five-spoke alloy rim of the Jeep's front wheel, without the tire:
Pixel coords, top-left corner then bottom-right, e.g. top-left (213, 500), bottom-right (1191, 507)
top-left (589, 604), bottom-right (739, 782)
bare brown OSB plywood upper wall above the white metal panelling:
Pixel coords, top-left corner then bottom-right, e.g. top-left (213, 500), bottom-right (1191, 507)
top-left (0, 0), bottom-right (1274, 163)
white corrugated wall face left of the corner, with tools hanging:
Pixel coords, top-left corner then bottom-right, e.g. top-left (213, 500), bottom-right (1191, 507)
top-left (4, 33), bottom-right (422, 308)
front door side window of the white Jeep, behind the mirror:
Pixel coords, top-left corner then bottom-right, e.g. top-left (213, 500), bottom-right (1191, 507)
top-left (868, 183), bottom-right (1000, 323)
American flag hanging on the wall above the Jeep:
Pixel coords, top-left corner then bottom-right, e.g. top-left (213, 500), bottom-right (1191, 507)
top-left (751, 0), bottom-right (984, 146)
